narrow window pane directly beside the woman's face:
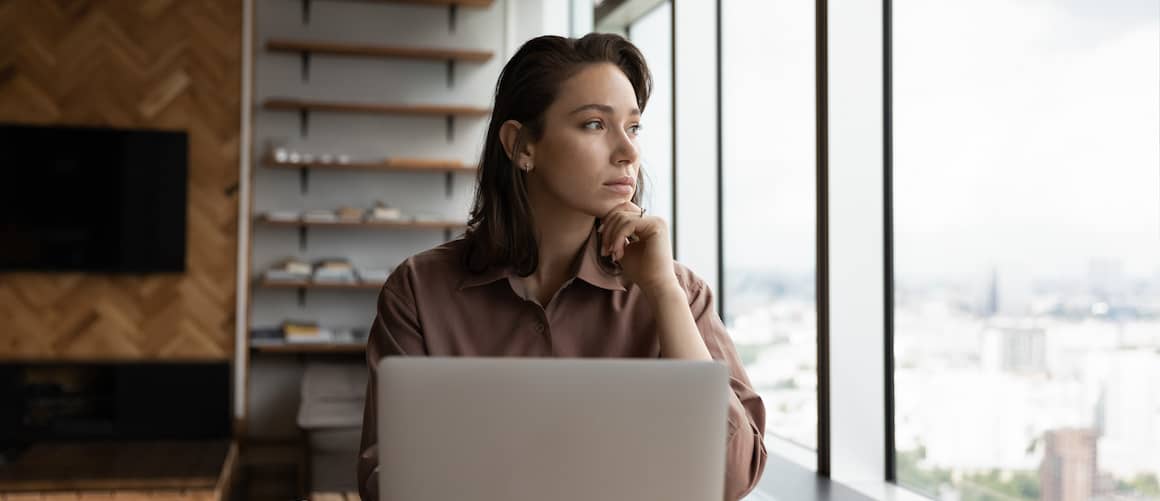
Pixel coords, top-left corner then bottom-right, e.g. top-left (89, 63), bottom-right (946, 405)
top-left (629, 1), bottom-right (675, 225)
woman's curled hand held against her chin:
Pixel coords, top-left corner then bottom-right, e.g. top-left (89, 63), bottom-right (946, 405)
top-left (597, 202), bottom-right (680, 293)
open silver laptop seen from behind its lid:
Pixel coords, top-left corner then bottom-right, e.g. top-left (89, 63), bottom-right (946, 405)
top-left (378, 357), bottom-right (728, 501)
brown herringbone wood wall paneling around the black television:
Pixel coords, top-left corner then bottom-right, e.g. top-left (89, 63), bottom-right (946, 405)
top-left (0, 0), bottom-right (241, 360)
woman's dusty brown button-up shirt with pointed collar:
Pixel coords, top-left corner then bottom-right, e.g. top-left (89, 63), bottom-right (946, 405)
top-left (358, 228), bottom-right (766, 500)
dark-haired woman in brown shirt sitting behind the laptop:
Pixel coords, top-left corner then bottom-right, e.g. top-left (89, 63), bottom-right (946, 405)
top-left (358, 34), bottom-right (766, 500)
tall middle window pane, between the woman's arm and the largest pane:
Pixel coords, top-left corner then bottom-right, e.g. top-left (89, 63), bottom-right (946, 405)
top-left (722, 0), bottom-right (818, 449)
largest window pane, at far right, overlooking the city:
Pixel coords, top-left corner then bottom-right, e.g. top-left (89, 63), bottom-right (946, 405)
top-left (893, 0), bottom-right (1160, 500)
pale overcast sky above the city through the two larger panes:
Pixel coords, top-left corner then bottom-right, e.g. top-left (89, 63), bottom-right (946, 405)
top-left (714, 0), bottom-right (1160, 284)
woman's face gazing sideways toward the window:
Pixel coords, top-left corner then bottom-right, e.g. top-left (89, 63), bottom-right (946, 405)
top-left (528, 64), bottom-right (640, 217)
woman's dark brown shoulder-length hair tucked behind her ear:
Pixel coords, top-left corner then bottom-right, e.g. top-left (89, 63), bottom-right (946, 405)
top-left (466, 34), bottom-right (652, 276)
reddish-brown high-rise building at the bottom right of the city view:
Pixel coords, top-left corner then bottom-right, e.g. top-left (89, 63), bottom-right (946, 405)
top-left (1039, 428), bottom-right (1097, 501)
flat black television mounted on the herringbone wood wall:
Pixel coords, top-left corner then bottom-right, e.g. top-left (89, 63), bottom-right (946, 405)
top-left (0, 123), bottom-right (188, 274)
